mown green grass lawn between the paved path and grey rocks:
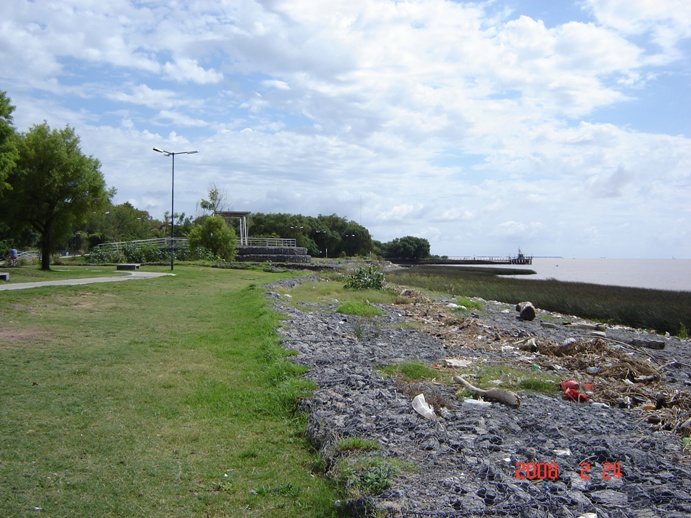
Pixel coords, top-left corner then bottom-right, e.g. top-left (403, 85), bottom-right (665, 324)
top-left (0, 266), bottom-right (338, 517)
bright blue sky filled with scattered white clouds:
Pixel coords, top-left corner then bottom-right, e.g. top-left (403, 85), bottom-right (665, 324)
top-left (0, 0), bottom-right (691, 258)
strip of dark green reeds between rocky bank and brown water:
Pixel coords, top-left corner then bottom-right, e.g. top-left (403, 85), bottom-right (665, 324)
top-left (387, 265), bottom-right (691, 338)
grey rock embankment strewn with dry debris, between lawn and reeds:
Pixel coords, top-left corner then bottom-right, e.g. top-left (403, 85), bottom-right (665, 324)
top-left (270, 279), bottom-right (691, 517)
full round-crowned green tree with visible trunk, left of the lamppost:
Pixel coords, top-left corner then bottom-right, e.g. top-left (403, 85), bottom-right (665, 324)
top-left (5, 122), bottom-right (109, 270)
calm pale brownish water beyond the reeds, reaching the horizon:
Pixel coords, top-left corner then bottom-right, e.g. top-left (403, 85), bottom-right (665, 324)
top-left (478, 258), bottom-right (691, 291)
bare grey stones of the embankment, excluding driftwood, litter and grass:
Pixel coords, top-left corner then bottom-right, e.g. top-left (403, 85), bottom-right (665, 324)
top-left (274, 278), bottom-right (691, 517)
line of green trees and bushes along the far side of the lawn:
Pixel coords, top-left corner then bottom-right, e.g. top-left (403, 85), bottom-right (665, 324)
top-left (0, 91), bottom-right (430, 270)
